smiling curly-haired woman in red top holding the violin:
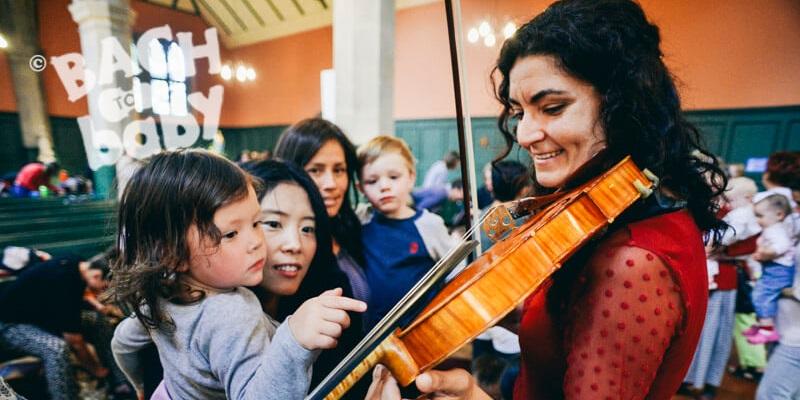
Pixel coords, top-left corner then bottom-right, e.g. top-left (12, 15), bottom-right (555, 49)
top-left (373, 0), bottom-right (725, 399)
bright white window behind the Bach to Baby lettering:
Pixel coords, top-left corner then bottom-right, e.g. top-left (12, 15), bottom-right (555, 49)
top-left (133, 39), bottom-right (188, 116)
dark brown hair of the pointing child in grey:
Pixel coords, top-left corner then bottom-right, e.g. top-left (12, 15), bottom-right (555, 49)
top-left (107, 150), bottom-right (258, 329)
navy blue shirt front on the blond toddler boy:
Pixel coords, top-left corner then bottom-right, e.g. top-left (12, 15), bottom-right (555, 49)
top-left (361, 211), bottom-right (435, 329)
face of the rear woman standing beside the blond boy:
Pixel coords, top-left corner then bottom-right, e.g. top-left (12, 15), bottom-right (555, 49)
top-left (304, 140), bottom-right (350, 217)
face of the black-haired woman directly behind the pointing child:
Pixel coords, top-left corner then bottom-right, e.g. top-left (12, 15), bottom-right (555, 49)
top-left (261, 183), bottom-right (317, 296)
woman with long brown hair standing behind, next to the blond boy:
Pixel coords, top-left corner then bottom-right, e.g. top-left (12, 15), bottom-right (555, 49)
top-left (274, 118), bottom-right (370, 397)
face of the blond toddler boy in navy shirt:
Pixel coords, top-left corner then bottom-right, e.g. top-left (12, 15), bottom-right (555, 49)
top-left (360, 153), bottom-right (416, 219)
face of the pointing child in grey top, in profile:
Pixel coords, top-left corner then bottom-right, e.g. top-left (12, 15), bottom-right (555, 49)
top-left (187, 187), bottom-right (264, 290)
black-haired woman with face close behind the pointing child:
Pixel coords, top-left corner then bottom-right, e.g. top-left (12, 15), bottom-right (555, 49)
top-left (242, 160), bottom-right (363, 396)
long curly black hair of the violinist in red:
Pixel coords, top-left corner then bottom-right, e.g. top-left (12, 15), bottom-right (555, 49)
top-left (492, 0), bottom-right (726, 234)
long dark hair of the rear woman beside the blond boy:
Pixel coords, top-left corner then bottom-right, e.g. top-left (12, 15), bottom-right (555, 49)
top-left (275, 118), bottom-right (364, 265)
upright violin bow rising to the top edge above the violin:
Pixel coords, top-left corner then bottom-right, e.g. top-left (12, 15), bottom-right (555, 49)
top-left (444, 0), bottom-right (483, 256)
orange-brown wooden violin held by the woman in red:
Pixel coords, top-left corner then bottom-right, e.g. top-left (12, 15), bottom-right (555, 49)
top-left (307, 156), bottom-right (658, 400)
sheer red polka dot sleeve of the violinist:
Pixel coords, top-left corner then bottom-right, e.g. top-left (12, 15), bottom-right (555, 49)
top-left (564, 245), bottom-right (683, 399)
